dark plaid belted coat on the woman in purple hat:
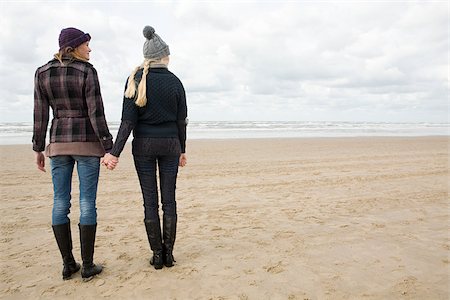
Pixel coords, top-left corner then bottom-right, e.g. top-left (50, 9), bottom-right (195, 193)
top-left (33, 59), bottom-right (112, 152)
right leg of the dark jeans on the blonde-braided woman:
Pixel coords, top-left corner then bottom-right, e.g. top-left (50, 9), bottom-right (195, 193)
top-left (158, 155), bottom-right (180, 217)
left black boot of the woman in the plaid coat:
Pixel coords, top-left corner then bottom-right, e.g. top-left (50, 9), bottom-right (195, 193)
top-left (52, 222), bottom-right (80, 280)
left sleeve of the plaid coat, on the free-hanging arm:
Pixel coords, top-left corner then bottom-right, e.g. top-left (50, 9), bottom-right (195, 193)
top-left (33, 70), bottom-right (50, 152)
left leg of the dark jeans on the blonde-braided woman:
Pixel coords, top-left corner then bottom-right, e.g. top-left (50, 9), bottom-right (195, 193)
top-left (133, 155), bottom-right (159, 220)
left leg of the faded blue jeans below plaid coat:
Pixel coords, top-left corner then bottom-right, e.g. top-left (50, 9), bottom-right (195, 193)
top-left (50, 155), bottom-right (75, 225)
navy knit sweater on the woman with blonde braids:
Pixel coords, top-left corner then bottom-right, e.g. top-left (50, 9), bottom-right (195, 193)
top-left (110, 68), bottom-right (187, 156)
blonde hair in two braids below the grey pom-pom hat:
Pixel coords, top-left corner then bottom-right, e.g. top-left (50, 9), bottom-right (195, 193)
top-left (124, 56), bottom-right (169, 107)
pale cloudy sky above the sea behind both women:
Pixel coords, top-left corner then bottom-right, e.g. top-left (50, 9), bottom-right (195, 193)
top-left (0, 0), bottom-right (449, 123)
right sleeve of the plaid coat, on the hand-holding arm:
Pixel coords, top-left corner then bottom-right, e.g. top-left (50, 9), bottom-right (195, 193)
top-left (85, 67), bottom-right (112, 152)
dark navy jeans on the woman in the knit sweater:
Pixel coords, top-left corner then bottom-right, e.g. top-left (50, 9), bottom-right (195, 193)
top-left (133, 155), bottom-right (180, 220)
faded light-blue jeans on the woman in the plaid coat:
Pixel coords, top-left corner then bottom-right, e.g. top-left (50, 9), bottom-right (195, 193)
top-left (50, 155), bottom-right (100, 225)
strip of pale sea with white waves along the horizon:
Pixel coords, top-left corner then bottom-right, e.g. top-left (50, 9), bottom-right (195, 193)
top-left (0, 121), bottom-right (450, 145)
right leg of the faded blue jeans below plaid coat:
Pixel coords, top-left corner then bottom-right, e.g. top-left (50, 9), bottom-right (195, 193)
top-left (73, 156), bottom-right (100, 225)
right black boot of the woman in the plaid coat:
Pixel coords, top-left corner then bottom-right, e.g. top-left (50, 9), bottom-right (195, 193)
top-left (78, 224), bottom-right (103, 281)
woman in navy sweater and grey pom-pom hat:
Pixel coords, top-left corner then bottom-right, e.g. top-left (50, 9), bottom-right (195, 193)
top-left (103, 26), bottom-right (187, 269)
